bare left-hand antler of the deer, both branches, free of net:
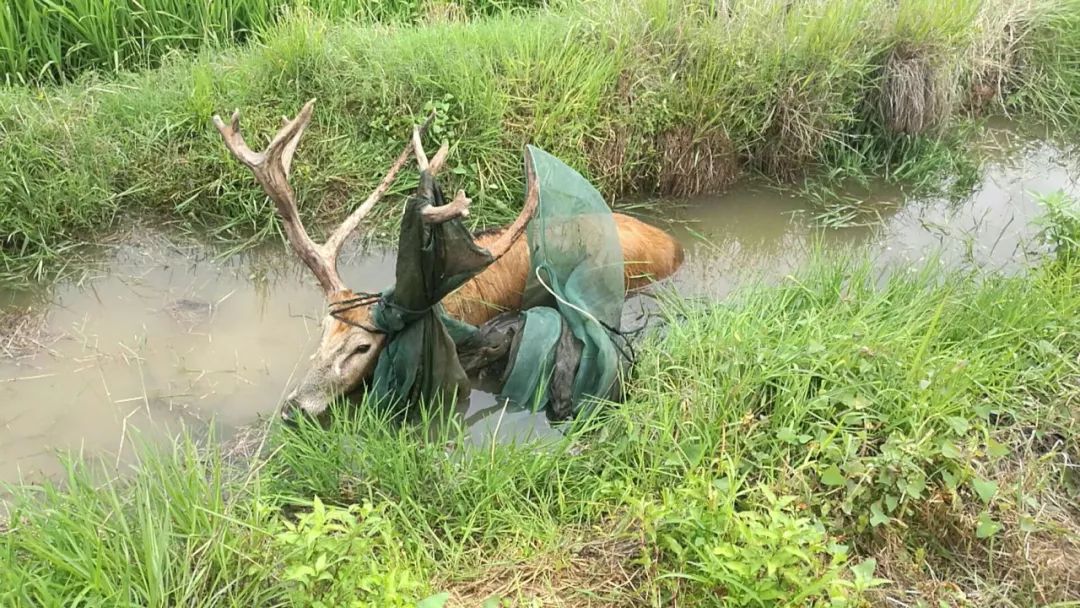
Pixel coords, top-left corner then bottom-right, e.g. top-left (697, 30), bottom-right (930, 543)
top-left (214, 99), bottom-right (434, 294)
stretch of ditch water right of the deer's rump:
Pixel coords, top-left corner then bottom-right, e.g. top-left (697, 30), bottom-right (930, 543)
top-left (675, 139), bottom-right (1080, 296)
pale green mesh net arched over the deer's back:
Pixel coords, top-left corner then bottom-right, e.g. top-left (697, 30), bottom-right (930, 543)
top-left (501, 146), bottom-right (625, 416)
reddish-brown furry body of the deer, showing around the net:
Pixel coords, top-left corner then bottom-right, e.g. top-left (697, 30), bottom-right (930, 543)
top-left (443, 214), bottom-right (684, 325)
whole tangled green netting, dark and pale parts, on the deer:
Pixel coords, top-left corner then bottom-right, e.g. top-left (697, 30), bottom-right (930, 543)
top-left (373, 146), bottom-right (629, 418)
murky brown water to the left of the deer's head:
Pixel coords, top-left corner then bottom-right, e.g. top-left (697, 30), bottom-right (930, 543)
top-left (0, 239), bottom-right (393, 488)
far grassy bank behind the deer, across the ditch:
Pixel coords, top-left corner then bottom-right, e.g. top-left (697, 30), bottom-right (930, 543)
top-left (0, 0), bottom-right (1080, 280)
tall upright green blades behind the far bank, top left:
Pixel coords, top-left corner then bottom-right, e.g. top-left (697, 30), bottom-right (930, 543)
top-left (0, 0), bottom-right (545, 83)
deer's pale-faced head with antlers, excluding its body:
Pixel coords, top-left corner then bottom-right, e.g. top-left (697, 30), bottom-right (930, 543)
top-left (214, 99), bottom-right (470, 419)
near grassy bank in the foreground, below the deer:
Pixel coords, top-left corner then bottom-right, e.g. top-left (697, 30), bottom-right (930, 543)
top-left (0, 199), bottom-right (1080, 607)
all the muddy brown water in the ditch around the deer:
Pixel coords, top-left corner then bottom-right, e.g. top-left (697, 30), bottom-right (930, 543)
top-left (0, 136), bottom-right (1080, 482)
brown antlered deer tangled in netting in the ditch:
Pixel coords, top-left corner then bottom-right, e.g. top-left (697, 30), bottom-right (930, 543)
top-left (213, 98), bottom-right (684, 421)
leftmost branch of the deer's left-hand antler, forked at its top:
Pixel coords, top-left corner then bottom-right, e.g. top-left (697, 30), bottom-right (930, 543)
top-left (214, 99), bottom-right (345, 294)
